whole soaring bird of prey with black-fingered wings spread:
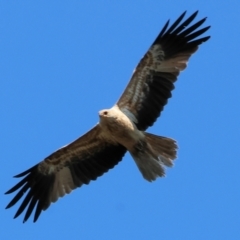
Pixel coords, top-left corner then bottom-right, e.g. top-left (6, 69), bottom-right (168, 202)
top-left (6, 12), bottom-right (210, 222)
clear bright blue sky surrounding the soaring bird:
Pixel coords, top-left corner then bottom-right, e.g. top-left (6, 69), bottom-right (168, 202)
top-left (0, 0), bottom-right (240, 240)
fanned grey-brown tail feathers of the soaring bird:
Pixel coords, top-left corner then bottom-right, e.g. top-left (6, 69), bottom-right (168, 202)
top-left (130, 133), bottom-right (177, 182)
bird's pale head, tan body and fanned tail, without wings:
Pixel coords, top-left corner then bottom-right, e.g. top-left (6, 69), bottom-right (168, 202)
top-left (99, 106), bottom-right (177, 181)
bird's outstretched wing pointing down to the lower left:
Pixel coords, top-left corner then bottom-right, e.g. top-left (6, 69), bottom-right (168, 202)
top-left (6, 125), bottom-right (126, 222)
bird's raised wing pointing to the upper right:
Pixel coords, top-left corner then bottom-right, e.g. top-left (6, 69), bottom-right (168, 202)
top-left (117, 12), bottom-right (210, 130)
